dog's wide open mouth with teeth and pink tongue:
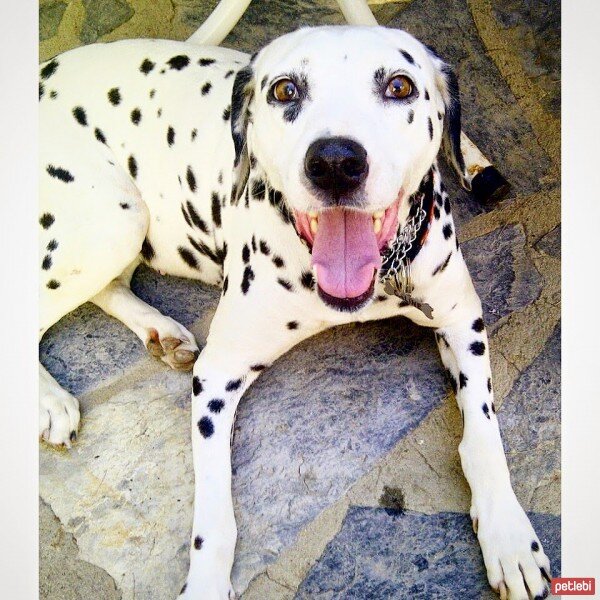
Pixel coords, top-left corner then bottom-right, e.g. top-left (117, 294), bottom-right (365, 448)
top-left (294, 194), bottom-right (401, 311)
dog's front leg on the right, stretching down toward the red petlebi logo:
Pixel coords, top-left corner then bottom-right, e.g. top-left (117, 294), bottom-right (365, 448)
top-left (436, 302), bottom-right (550, 600)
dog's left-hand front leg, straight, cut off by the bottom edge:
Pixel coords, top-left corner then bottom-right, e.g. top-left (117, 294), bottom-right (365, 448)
top-left (180, 300), bottom-right (321, 600)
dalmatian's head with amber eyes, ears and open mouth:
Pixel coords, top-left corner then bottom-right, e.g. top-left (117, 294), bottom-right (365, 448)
top-left (231, 27), bottom-right (464, 310)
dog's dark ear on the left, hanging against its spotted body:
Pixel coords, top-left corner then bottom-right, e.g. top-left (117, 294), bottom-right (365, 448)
top-left (231, 63), bottom-right (254, 203)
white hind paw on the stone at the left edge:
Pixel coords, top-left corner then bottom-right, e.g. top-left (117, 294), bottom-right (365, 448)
top-left (39, 385), bottom-right (79, 448)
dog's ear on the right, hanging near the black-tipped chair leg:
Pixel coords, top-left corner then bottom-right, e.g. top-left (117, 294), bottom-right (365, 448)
top-left (427, 46), bottom-right (471, 190)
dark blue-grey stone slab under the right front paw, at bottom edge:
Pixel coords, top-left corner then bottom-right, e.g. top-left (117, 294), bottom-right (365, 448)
top-left (295, 507), bottom-right (561, 600)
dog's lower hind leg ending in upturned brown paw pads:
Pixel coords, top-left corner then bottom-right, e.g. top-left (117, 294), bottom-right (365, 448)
top-left (91, 259), bottom-right (199, 371)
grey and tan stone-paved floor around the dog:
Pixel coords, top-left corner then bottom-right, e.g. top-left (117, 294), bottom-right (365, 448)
top-left (40, 0), bottom-right (560, 600)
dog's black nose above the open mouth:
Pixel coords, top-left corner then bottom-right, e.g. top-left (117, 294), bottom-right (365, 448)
top-left (304, 137), bottom-right (369, 196)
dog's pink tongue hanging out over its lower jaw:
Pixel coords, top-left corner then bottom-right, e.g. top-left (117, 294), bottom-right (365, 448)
top-left (312, 208), bottom-right (381, 298)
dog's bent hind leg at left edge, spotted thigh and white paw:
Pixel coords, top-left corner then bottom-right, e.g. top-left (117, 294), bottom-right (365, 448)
top-left (39, 119), bottom-right (149, 445)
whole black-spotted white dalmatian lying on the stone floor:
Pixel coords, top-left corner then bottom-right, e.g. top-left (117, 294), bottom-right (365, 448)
top-left (39, 26), bottom-right (550, 600)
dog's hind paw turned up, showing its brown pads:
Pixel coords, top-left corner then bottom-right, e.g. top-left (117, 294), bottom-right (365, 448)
top-left (146, 315), bottom-right (200, 371)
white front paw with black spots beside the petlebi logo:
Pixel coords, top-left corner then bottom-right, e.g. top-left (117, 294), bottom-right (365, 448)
top-left (471, 490), bottom-right (550, 600)
